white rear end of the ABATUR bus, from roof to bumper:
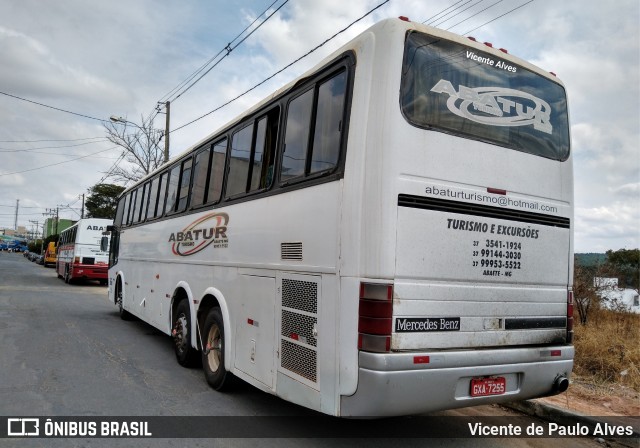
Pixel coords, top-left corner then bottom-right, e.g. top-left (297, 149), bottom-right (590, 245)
top-left (340, 20), bottom-right (574, 416)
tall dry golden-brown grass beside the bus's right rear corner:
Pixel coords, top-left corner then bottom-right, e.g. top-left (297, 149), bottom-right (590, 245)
top-left (574, 310), bottom-right (640, 391)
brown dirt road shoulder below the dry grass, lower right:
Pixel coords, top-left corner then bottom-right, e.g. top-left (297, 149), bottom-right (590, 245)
top-left (532, 378), bottom-right (640, 417)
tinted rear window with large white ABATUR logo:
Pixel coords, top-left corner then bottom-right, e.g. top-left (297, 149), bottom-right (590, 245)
top-left (400, 32), bottom-right (569, 161)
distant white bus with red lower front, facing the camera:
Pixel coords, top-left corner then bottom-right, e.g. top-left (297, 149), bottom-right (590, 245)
top-left (56, 218), bottom-right (112, 285)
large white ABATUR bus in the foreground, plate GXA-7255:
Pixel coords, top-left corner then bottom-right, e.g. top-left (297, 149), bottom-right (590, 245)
top-left (109, 18), bottom-right (574, 416)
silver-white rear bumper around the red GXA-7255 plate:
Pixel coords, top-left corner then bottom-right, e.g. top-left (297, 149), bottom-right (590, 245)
top-left (340, 346), bottom-right (574, 417)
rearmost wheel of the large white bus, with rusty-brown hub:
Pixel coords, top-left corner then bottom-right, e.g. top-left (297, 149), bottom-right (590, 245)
top-left (202, 308), bottom-right (234, 391)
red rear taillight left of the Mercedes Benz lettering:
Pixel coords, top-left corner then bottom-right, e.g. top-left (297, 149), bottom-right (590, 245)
top-left (358, 283), bottom-right (393, 352)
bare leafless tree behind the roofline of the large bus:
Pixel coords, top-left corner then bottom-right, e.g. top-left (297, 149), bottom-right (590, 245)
top-left (104, 118), bottom-right (164, 182)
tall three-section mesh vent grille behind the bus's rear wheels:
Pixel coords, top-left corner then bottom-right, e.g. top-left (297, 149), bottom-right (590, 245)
top-left (280, 274), bottom-right (320, 389)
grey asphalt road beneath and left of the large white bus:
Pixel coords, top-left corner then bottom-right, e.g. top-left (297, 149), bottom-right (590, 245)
top-left (0, 252), bottom-right (620, 448)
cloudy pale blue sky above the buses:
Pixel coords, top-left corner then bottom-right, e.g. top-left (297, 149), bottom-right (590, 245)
top-left (0, 0), bottom-right (640, 252)
